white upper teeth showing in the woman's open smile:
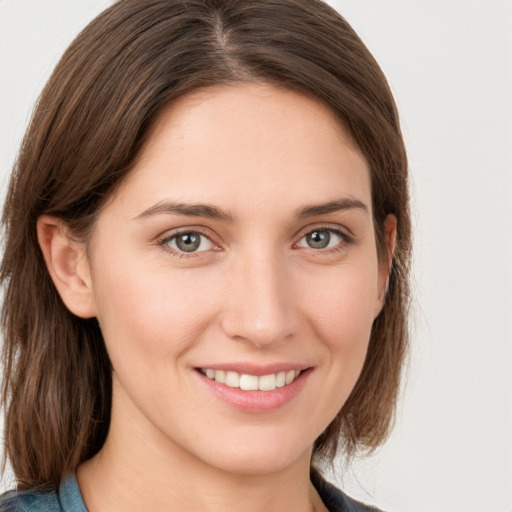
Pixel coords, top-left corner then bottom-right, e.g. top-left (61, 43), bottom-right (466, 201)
top-left (198, 368), bottom-right (302, 391)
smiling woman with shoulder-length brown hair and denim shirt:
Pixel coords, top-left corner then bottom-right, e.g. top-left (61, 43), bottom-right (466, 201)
top-left (1, 0), bottom-right (410, 512)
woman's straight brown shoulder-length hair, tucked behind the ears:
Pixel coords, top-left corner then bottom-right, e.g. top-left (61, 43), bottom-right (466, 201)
top-left (0, 0), bottom-right (410, 488)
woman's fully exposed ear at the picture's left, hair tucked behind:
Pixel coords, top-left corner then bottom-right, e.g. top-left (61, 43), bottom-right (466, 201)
top-left (37, 215), bottom-right (96, 318)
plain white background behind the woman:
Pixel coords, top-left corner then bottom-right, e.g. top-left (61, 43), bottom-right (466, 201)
top-left (0, 0), bottom-right (512, 512)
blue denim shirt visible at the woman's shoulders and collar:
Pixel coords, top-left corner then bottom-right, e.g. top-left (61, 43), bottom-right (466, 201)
top-left (0, 469), bottom-right (380, 512)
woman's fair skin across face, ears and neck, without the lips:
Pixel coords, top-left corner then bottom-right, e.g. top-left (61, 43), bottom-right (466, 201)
top-left (38, 84), bottom-right (396, 512)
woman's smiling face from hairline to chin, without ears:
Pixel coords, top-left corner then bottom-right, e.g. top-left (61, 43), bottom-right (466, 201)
top-left (83, 85), bottom-right (389, 473)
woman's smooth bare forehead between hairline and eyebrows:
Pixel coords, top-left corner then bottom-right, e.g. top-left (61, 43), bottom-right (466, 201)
top-left (109, 84), bottom-right (371, 218)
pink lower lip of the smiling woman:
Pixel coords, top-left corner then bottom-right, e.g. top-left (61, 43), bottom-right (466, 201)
top-left (195, 368), bottom-right (311, 413)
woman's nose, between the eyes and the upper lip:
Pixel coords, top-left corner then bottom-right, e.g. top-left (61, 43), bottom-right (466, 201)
top-left (221, 254), bottom-right (299, 348)
